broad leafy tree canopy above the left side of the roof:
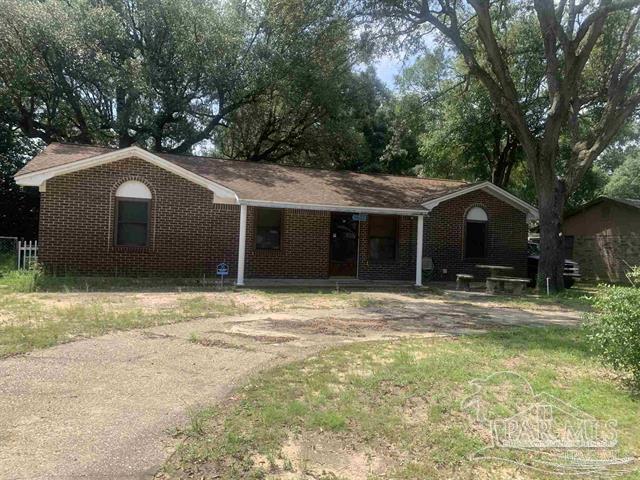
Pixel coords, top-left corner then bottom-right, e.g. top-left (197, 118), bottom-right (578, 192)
top-left (0, 0), bottom-right (350, 153)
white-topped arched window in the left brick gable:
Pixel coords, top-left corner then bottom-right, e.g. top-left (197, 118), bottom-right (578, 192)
top-left (114, 180), bottom-right (151, 247)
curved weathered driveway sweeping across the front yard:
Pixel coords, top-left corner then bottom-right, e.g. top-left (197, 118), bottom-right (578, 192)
top-left (0, 294), bottom-right (579, 480)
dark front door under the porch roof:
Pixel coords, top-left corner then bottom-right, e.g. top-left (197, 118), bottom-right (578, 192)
top-left (329, 213), bottom-right (358, 277)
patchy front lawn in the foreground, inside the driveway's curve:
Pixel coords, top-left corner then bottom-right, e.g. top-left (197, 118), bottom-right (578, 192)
top-left (158, 327), bottom-right (640, 480)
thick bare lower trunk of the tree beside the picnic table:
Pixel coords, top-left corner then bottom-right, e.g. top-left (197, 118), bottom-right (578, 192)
top-left (537, 178), bottom-right (565, 293)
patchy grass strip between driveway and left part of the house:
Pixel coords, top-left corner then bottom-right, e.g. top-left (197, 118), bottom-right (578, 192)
top-left (0, 277), bottom-right (369, 358)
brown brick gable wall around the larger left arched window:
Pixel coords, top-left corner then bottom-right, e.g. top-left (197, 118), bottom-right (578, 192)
top-left (40, 158), bottom-right (239, 276)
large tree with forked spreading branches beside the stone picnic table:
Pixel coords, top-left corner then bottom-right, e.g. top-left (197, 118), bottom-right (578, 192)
top-left (366, 0), bottom-right (640, 290)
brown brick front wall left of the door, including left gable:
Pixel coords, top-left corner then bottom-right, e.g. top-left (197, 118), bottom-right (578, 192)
top-left (40, 159), bottom-right (330, 278)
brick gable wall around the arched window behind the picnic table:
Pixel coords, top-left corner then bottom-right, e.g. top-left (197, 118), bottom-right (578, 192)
top-left (423, 191), bottom-right (527, 280)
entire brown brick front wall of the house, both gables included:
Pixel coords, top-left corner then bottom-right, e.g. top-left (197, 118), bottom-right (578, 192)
top-left (39, 159), bottom-right (527, 280)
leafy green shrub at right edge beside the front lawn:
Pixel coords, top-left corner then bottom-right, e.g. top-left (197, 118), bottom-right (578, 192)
top-left (586, 285), bottom-right (640, 388)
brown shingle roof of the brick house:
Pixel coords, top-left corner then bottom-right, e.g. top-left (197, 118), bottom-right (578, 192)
top-left (17, 143), bottom-right (469, 209)
